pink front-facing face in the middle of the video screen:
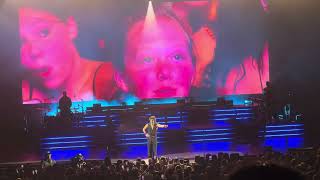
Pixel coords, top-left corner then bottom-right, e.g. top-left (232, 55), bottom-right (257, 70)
top-left (125, 16), bottom-right (195, 99)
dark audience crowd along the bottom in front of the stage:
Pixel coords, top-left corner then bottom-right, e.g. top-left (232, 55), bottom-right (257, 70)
top-left (7, 149), bottom-right (320, 180)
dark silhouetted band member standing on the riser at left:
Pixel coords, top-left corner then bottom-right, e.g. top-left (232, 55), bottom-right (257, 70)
top-left (59, 91), bottom-right (72, 126)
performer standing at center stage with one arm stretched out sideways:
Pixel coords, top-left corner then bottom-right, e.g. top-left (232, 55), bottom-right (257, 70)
top-left (142, 116), bottom-right (168, 158)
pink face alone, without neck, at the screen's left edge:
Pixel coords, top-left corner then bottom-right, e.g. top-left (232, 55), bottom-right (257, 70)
top-left (19, 8), bottom-right (75, 89)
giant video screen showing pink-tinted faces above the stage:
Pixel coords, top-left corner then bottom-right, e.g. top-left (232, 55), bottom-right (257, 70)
top-left (18, 0), bottom-right (269, 104)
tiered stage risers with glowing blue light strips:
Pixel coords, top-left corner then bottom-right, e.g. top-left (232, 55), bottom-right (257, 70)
top-left (15, 102), bottom-right (304, 161)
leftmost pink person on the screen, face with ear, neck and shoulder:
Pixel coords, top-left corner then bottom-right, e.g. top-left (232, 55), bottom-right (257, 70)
top-left (19, 7), bottom-right (111, 103)
